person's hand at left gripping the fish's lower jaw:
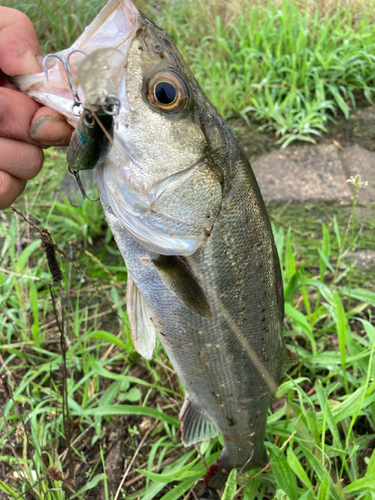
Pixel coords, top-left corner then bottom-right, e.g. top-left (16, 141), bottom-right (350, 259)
top-left (0, 7), bottom-right (73, 209)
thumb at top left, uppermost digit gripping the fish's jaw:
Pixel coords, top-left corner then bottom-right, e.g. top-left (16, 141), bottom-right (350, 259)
top-left (0, 7), bottom-right (43, 76)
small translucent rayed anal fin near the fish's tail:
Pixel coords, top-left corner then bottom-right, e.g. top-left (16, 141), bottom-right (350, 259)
top-left (179, 398), bottom-right (219, 446)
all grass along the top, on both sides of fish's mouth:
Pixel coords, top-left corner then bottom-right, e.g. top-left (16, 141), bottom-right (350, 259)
top-left (5, 0), bottom-right (375, 147)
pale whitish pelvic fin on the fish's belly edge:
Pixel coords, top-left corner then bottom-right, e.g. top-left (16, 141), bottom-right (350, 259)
top-left (126, 276), bottom-right (156, 359)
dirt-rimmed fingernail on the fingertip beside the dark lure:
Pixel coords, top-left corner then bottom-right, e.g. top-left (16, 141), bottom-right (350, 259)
top-left (29, 115), bottom-right (72, 147)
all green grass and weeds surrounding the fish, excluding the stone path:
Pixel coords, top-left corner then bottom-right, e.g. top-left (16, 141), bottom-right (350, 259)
top-left (0, 0), bottom-right (375, 500)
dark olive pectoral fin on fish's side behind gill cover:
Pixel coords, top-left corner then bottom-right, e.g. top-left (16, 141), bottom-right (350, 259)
top-left (152, 255), bottom-right (213, 318)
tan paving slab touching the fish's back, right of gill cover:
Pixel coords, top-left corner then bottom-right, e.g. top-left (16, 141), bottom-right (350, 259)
top-left (250, 144), bottom-right (352, 203)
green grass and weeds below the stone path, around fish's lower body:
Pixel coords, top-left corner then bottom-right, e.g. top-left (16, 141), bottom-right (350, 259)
top-left (0, 153), bottom-right (375, 500)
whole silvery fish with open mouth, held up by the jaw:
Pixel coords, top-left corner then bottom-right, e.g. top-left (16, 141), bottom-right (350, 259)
top-left (13, 0), bottom-right (284, 489)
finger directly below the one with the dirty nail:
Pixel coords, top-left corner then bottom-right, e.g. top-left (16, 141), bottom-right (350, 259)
top-left (0, 137), bottom-right (43, 181)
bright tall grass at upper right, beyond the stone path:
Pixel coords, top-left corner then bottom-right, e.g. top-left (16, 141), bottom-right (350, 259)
top-left (160, 0), bottom-right (375, 146)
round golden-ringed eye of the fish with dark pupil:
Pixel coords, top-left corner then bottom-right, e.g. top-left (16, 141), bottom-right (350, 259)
top-left (147, 71), bottom-right (189, 113)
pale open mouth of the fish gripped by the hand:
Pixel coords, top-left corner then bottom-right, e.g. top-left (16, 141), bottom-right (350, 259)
top-left (13, 0), bottom-right (139, 126)
